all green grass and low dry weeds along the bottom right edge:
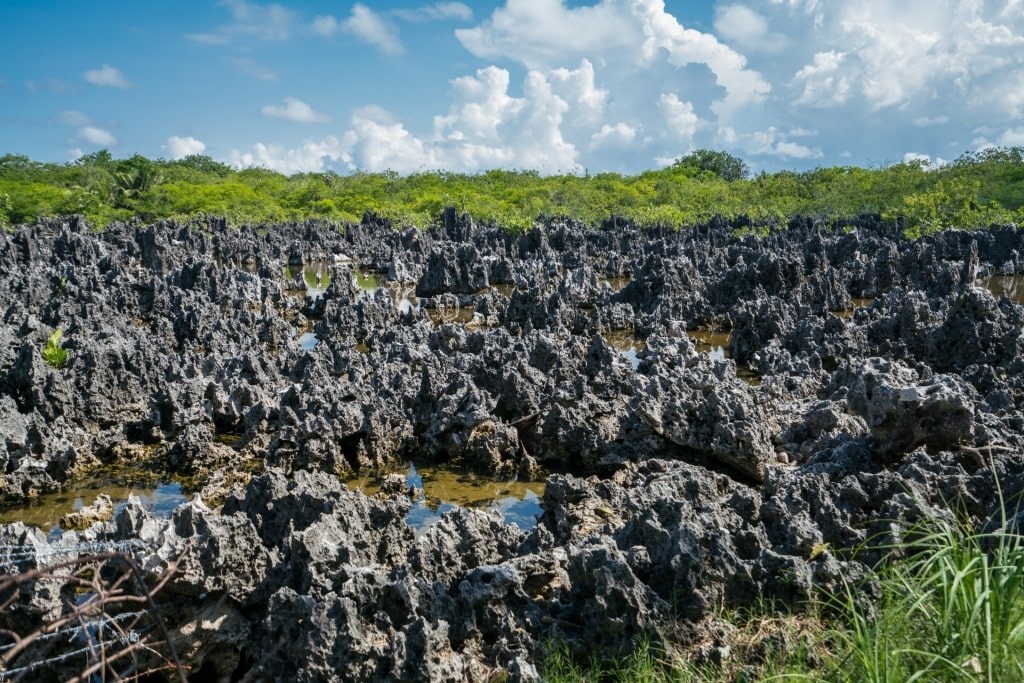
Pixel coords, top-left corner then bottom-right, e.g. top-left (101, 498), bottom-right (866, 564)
top-left (542, 499), bottom-right (1024, 683)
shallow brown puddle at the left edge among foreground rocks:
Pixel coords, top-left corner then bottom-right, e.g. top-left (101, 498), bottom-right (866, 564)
top-left (0, 470), bottom-right (188, 535)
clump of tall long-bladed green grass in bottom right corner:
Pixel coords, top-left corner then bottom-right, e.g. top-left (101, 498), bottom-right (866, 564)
top-left (830, 499), bottom-right (1024, 683)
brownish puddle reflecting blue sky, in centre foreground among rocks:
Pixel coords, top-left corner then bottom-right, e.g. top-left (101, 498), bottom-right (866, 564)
top-left (348, 465), bottom-right (544, 533)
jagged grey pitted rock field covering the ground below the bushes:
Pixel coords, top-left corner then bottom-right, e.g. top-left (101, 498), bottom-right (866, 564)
top-left (0, 215), bottom-right (1024, 681)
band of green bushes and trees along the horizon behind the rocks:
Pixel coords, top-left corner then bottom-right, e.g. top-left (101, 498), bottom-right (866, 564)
top-left (0, 147), bottom-right (1024, 237)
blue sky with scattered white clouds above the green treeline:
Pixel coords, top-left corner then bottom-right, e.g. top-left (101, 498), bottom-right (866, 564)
top-left (0, 0), bottom-right (1024, 173)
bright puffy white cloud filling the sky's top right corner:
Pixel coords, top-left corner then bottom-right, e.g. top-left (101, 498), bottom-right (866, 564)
top-left (774, 0), bottom-right (1024, 118)
